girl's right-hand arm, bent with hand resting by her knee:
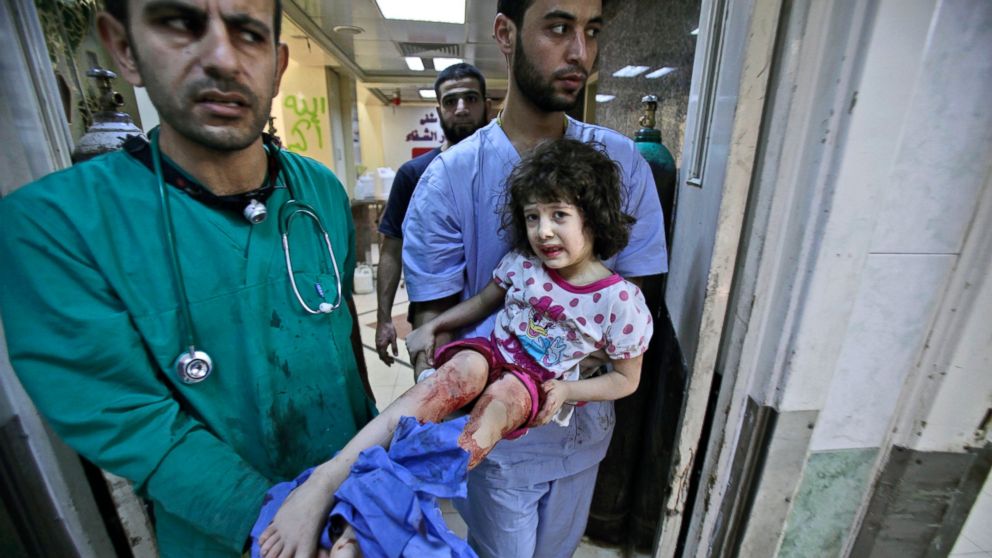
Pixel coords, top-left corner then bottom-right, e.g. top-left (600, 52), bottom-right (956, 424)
top-left (533, 355), bottom-right (644, 426)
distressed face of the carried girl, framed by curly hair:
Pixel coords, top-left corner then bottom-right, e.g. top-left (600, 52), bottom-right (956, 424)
top-left (523, 202), bottom-right (595, 279)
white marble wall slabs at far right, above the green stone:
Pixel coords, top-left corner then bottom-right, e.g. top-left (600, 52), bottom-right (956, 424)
top-left (812, 0), bottom-right (992, 450)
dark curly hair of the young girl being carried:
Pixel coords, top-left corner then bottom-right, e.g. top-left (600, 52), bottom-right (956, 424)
top-left (501, 138), bottom-right (636, 260)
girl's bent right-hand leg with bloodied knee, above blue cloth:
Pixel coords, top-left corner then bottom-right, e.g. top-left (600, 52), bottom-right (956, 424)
top-left (458, 374), bottom-right (531, 469)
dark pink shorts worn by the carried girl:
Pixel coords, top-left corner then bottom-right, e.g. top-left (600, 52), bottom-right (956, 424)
top-left (434, 337), bottom-right (555, 440)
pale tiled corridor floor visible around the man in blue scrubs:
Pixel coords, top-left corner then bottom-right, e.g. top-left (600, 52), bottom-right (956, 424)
top-left (355, 287), bottom-right (621, 558)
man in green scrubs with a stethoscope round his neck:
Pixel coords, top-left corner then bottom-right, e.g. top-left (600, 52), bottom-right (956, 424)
top-left (0, 0), bottom-right (374, 557)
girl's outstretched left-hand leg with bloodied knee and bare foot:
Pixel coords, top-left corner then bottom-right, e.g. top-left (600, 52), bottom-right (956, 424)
top-left (259, 351), bottom-right (486, 558)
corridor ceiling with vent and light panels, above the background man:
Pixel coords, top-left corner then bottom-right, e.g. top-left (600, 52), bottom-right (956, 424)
top-left (283, 0), bottom-right (506, 104)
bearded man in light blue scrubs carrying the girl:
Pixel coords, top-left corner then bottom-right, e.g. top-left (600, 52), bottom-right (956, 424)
top-left (403, 0), bottom-right (667, 558)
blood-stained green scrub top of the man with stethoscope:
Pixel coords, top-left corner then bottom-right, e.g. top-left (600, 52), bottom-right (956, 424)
top-left (0, 147), bottom-right (375, 557)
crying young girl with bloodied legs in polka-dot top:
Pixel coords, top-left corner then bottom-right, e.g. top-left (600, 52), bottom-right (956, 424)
top-left (260, 139), bottom-right (652, 558)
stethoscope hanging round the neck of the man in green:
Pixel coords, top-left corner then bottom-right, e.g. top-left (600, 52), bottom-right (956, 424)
top-left (150, 130), bottom-right (342, 384)
